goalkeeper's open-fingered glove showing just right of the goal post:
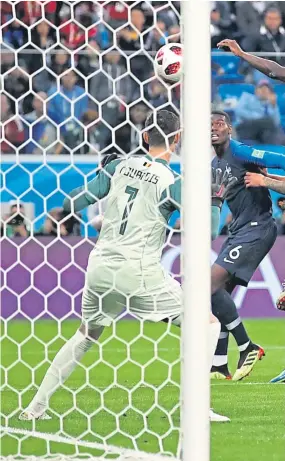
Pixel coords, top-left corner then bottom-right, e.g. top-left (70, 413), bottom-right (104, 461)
top-left (212, 168), bottom-right (238, 208)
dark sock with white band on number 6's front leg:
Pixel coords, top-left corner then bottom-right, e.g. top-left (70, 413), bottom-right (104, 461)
top-left (212, 289), bottom-right (250, 351)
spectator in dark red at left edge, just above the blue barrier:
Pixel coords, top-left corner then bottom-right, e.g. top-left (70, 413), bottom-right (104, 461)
top-left (0, 93), bottom-right (25, 154)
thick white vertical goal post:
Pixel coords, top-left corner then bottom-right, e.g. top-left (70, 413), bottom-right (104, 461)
top-left (182, 0), bottom-right (211, 461)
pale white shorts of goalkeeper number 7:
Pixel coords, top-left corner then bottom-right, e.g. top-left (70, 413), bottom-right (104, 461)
top-left (82, 252), bottom-right (182, 327)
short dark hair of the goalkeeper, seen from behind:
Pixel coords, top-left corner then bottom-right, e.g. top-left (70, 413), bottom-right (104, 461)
top-left (145, 109), bottom-right (180, 147)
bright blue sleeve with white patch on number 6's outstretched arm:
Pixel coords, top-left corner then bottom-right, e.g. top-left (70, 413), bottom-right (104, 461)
top-left (230, 139), bottom-right (285, 170)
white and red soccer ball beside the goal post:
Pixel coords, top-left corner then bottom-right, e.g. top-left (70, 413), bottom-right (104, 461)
top-left (154, 43), bottom-right (183, 83)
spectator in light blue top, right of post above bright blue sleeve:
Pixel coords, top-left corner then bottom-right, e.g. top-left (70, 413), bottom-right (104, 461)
top-left (235, 80), bottom-right (284, 144)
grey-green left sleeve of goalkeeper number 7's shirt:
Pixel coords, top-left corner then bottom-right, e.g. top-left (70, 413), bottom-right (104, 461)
top-left (63, 160), bottom-right (121, 212)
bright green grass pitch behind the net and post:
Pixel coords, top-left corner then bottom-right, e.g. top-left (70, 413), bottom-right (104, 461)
top-left (1, 320), bottom-right (285, 461)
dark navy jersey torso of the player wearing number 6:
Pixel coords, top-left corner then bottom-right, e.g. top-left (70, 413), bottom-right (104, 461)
top-left (212, 147), bottom-right (273, 233)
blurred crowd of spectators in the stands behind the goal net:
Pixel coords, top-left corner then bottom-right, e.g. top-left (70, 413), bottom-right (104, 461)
top-left (1, 0), bottom-right (285, 155)
